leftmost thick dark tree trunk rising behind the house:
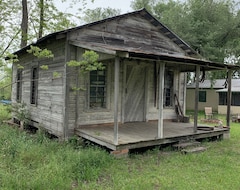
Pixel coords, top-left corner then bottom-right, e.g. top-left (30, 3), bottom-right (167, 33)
top-left (20, 0), bottom-right (28, 48)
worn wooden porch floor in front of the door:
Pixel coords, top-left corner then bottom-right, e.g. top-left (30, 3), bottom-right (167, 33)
top-left (76, 121), bottom-right (229, 150)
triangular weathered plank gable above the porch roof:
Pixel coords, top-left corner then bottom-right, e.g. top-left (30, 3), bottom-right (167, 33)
top-left (69, 15), bottom-right (184, 55)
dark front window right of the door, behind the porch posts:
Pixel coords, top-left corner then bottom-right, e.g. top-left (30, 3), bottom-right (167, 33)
top-left (164, 70), bottom-right (174, 107)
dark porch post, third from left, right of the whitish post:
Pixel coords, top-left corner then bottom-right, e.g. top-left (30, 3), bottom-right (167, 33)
top-left (193, 65), bottom-right (200, 133)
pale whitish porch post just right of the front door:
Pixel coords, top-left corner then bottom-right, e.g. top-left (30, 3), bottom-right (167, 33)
top-left (157, 62), bottom-right (165, 138)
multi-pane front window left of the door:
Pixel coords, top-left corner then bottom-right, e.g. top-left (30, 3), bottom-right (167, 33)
top-left (89, 70), bottom-right (106, 108)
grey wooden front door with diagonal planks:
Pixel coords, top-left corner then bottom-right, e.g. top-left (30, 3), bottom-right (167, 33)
top-left (124, 64), bottom-right (146, 122)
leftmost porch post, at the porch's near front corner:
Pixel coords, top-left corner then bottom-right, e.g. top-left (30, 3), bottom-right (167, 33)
top-left (114, 56), bottom-right (120, 145)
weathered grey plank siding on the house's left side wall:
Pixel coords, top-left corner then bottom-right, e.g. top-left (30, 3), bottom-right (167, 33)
top-left (12, 40), bottom-right (65, 137)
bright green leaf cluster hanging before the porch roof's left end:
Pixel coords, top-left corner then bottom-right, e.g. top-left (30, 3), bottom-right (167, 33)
top-left (67, 51), bottom-right (105, 73)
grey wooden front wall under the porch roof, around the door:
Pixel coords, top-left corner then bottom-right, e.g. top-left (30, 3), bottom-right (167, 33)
top-left (75, 49), bottom-right (184, 126)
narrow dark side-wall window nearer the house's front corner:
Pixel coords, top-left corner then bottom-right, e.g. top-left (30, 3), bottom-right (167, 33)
top-left (30, 67), bottom-right (38, 104)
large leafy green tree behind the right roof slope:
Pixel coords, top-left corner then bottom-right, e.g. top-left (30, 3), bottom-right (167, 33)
top-left (132, 0), bottom-right (240, 79)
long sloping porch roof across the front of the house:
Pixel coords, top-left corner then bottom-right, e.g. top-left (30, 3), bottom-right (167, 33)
top-left (70, 41), bottom-right (240, 72)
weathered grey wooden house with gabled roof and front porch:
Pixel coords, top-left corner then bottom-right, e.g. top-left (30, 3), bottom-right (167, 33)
top-left (12, 9), bottom-right (238, 150)
